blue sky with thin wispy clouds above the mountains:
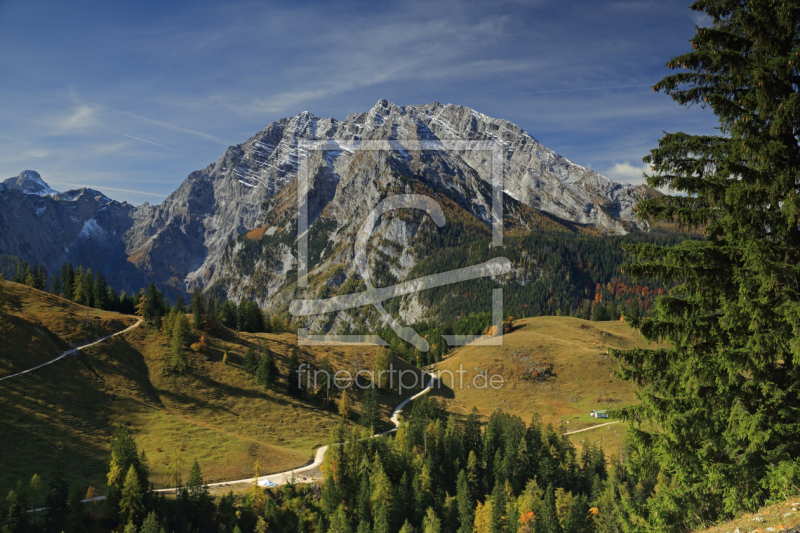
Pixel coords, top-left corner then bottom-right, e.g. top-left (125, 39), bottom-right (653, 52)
top-left (0, 0), bottom-right (716, 204)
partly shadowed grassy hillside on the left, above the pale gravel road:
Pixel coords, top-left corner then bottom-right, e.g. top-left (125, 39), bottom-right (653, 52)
top-left (0, 280), bottom-right (424, 493)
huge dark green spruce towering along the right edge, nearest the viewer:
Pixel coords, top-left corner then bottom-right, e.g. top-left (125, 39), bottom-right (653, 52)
top-left (614, 0), bottom-right (800, 521)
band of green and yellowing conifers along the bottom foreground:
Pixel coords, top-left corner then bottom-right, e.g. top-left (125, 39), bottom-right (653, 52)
top-left (0, 397), bottom-right (656, 533)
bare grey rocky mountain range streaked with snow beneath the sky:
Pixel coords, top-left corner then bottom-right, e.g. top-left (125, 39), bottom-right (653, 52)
top-left (0, 100), bottom-right (655, 305)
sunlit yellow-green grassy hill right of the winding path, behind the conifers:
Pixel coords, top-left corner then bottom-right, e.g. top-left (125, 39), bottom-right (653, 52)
top-left (428, 317), bottom-right (664, 452)
